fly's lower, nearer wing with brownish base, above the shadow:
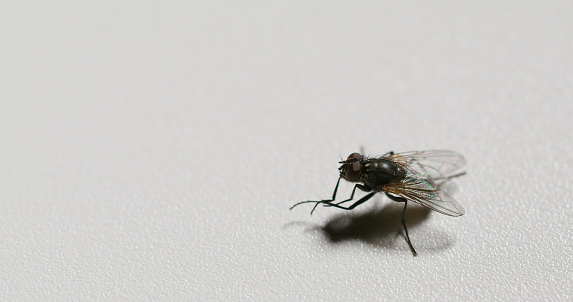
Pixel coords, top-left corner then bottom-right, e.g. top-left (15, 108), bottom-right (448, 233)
top-left (383, 177), bottom-right (465, 216)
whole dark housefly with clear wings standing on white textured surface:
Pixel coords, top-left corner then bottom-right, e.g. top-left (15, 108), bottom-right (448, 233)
top-left (291, 150), bottom-right (465, 256)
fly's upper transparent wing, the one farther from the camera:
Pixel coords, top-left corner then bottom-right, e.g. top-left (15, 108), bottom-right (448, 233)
top-left (386, 150), bottom-right (466, 180)
